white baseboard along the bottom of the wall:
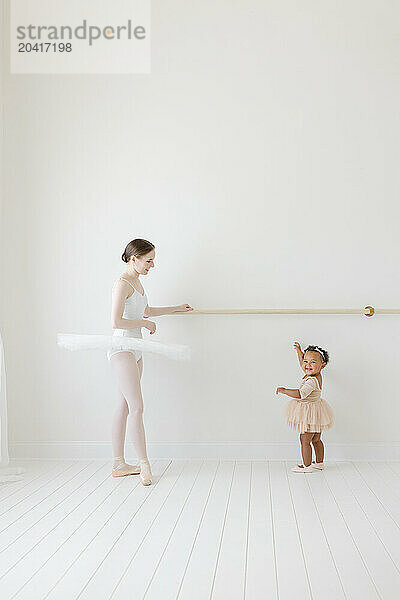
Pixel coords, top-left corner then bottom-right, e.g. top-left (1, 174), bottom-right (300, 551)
top-left (9, 442), bottom-right (400, 460)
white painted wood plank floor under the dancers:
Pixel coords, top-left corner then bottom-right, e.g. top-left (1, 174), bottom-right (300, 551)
top-left (0, 460), bottom-right (400, 600)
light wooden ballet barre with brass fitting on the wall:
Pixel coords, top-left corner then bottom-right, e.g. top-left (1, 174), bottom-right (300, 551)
top-left (171, 306), bottom-right (400, 317)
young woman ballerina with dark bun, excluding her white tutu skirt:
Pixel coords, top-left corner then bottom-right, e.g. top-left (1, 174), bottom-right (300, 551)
top-left (107, 239), bottom-right (193, 485)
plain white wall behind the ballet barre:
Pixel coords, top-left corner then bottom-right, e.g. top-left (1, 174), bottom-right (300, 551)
top-left (2, 0), bottom-right (400, 456)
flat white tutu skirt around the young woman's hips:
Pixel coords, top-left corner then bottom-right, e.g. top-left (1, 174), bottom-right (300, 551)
top-left (57, 333), bottom-right (190, 360)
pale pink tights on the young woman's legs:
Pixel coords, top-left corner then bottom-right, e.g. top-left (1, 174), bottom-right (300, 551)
top-left (110, 352), bottom-right (147, 460)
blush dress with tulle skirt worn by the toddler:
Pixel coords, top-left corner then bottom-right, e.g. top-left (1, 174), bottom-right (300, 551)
top-left (286, 375), bottom-right (334, 433)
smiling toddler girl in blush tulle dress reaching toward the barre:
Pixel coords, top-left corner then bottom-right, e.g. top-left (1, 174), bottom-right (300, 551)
top-left (276, 342), bottom-right (333, 473)
